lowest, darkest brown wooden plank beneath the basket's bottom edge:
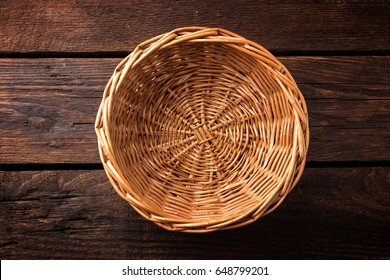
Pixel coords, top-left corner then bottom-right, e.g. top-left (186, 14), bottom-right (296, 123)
top-left (0, 167), bottom-right (390, 259)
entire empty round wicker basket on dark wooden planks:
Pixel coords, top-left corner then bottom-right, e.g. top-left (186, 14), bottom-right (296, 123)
top-left (96, 27), bottom-right (309, 232)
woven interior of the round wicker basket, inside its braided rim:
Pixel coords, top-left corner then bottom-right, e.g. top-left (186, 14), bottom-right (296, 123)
top-left (109, 43), bottom-right (297, 222)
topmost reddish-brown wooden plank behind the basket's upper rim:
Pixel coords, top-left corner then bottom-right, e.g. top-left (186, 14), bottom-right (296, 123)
top-left (0, 0), bottom-right (390, 53)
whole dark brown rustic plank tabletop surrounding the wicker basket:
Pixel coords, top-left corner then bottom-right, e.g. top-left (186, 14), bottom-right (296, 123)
top-left (0, 0), bottom-right (390, 259)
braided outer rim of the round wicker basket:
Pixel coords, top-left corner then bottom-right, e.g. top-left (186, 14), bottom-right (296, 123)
top-left (95, 26), bottom-right (309, 232)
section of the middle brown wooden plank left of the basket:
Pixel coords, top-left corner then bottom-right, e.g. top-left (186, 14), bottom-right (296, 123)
top-left (0, 59), bottom-right (109, 163)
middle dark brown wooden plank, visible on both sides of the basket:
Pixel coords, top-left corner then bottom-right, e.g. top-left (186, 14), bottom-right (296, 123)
top-left (0, 56), bottom-right (390, 163)
